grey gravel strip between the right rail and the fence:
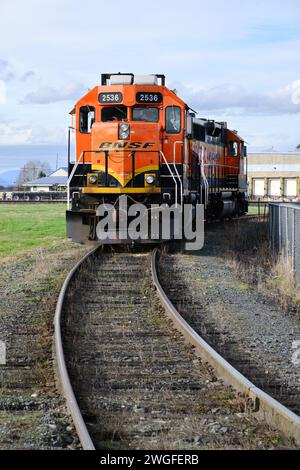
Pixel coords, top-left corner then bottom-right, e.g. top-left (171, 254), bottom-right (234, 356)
top-left (160, 224), bottom-right (300, 414)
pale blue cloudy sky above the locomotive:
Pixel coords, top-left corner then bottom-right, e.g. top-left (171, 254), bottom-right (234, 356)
top-left (0, 0), bottom-right (300, 177)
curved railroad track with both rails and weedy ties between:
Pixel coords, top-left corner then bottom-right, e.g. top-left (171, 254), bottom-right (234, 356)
top-left (55, 249), bottom-right (300, 450)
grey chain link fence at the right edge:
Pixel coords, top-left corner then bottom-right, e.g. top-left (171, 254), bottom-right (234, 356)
top-left (269, 203), bottom-right (300, 281)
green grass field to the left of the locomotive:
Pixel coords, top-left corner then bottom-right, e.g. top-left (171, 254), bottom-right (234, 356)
top-left (0, 203), bottom-right (67, 258)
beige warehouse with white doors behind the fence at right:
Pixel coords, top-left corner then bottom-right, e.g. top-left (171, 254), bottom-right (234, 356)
top-left (247, 152), bottom-right (300, 200)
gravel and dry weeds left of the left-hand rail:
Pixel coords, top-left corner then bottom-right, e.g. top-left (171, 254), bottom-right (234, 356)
top-left (0, 240), bottom-right (88, 450)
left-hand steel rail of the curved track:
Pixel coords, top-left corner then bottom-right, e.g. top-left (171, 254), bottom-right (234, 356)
top-left (54, 246), bottom-right (99, 450)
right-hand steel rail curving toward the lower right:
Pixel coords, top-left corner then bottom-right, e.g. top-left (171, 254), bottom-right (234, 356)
top-left (151, 248), bottom-right (300, 445)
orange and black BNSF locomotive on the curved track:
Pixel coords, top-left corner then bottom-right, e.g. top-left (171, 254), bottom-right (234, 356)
top-left (67, 73), bottom-right (247, 242)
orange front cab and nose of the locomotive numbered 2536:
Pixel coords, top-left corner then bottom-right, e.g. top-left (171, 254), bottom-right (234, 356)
top-left (70, 74), bottom-right (185, 194)
